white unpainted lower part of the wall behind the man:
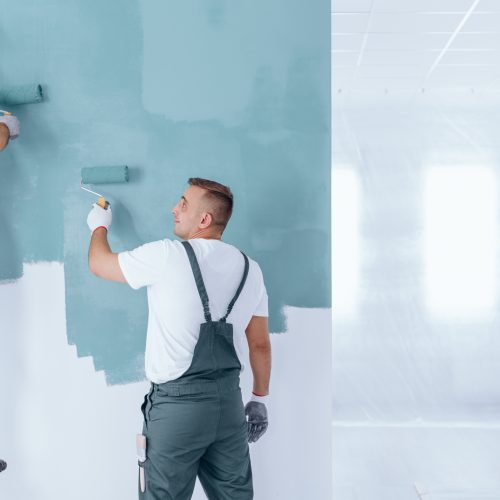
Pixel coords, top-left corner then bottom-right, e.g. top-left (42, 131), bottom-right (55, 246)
top-left (0, 262), bottom-right (332, 500)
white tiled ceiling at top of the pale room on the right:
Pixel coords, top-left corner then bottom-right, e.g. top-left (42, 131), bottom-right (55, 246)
top-left (332, 0), bottom-right (500, 91)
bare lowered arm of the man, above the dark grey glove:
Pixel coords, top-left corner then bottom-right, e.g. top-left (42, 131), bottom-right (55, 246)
top-left (245, 316), bottom-right (271, 396)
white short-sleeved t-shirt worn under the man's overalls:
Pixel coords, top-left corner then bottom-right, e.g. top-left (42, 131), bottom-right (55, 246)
top-left (118, 238), bottom-right (268, 384)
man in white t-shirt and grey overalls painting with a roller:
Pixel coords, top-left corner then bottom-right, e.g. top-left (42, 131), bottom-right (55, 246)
top-left (87, 178), bottom-right (271, 500)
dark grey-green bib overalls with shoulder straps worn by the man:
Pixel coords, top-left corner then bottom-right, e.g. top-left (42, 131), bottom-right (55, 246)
top-left (139, 241), bottom-right (253, 500)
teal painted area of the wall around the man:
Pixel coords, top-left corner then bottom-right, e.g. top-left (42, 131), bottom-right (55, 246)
top-left (0, 0), bottom-right (330, 384)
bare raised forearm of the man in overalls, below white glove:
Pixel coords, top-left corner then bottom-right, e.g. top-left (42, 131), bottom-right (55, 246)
top-left (89, 227), bottom-right (127, 283)
